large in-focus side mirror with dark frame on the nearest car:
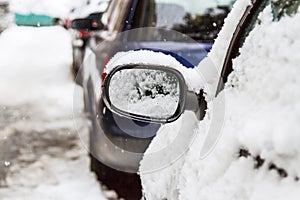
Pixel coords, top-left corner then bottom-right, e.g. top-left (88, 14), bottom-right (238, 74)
top-left (102, 64), bottom-right (203, 123)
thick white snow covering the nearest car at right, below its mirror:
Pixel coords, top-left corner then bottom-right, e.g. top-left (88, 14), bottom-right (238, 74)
top-left (141, 1), bottom-right (300, 200)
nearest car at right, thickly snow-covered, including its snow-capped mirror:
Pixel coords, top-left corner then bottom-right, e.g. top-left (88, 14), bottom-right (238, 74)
top-left (103, 0), bottom-right (300, 200)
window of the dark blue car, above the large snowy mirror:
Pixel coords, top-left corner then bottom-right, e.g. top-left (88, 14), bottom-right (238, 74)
top-left (131, 0), bottom-right (234, 42)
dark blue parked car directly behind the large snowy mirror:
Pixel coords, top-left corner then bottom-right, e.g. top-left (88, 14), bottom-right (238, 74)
top-left (79, 0), bottom-right (232, 199)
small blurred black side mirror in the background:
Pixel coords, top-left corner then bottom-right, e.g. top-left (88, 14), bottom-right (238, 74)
top-left (71, 18), bottom-right (104, 30)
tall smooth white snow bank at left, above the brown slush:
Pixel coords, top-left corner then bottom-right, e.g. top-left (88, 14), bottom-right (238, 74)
top-left (0, 27), bottom-right (74, 114)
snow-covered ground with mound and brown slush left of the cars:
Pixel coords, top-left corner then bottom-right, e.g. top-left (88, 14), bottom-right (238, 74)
top-left (0, 27), bottom-right (111, 200)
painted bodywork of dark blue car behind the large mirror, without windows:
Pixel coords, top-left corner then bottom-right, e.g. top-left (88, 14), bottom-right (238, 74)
top-left (83, 0), bottom-right (234, 171)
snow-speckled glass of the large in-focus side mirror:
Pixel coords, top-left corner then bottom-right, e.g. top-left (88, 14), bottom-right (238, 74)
top-left (108, 68), bottom-right (180, 118)
